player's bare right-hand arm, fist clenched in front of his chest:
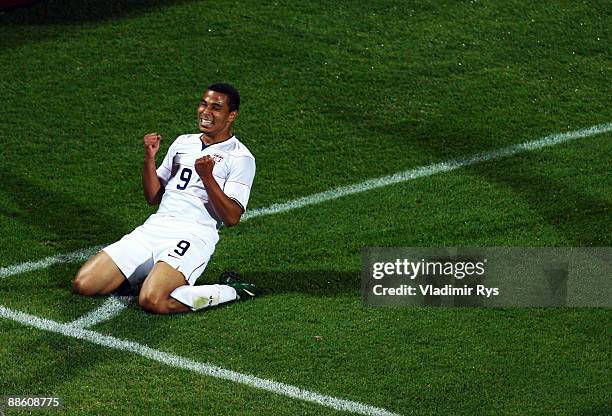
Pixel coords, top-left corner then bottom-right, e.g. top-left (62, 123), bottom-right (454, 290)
top-left (195, 156), bottom-right (242, 227)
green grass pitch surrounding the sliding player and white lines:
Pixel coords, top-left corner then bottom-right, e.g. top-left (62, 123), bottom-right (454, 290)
top-left (0, 0), bottom-right (612, 415)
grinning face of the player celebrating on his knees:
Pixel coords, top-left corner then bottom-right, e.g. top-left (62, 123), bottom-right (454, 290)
top-left (198, 90), bottom-right (237, 139)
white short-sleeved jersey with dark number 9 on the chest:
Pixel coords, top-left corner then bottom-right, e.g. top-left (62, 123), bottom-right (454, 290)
top-left (146, 134), bottom-right (255, 244)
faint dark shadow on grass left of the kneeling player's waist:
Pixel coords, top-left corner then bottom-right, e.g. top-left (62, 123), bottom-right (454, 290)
top-left (0, 171), bottom-right (129, 252)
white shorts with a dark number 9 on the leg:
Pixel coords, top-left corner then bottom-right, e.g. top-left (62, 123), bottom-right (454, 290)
top-left (103, 223), bottom-right (215, 285)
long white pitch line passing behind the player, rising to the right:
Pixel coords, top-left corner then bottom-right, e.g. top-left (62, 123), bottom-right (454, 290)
top-left (0, 123), bottom-right (612, 278)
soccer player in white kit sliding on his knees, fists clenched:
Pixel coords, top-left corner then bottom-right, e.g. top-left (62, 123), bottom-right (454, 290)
top-left (73, 84), bottom-right (259, 313)
